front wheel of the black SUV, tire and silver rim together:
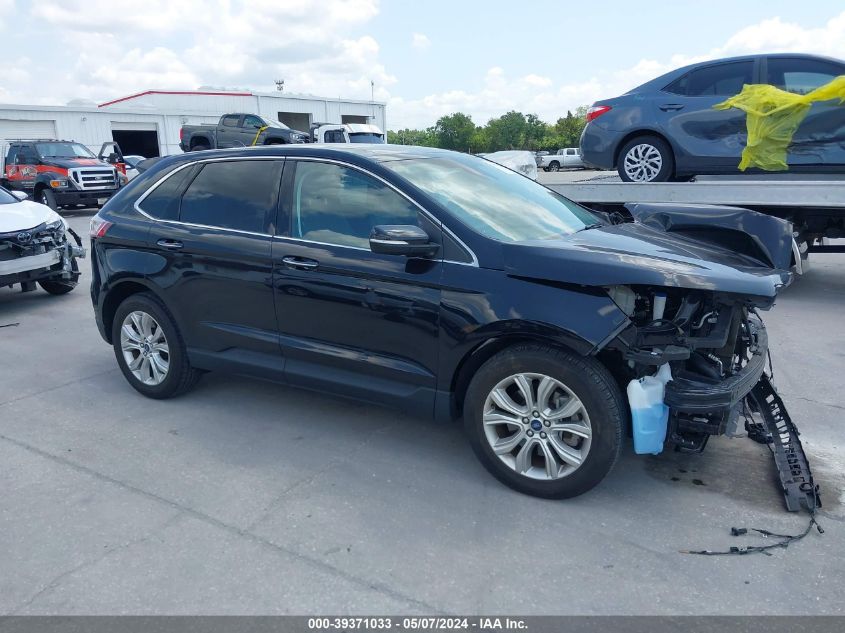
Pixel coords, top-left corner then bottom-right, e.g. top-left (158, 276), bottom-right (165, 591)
top-left (464, 345), bottom-right (625, 499)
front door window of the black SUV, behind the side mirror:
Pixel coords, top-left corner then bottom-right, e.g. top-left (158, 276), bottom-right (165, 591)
top-left (291, 162), bottom-right (417, 248)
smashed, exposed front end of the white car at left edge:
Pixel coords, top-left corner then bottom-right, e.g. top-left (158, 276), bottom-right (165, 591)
top-left (0, 218), bottom-right (85, 292)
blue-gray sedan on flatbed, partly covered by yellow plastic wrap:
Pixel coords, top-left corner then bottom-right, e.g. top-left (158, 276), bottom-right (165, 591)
top-left (581, 54), bottom-right (845, 182)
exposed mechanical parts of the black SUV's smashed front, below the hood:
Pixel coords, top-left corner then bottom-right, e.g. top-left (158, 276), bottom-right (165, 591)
top-left (608, 287), bottom-right (768, 452)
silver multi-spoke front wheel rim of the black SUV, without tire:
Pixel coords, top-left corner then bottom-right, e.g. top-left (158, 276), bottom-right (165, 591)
top-left (482, 374), bottom-right (593, 480)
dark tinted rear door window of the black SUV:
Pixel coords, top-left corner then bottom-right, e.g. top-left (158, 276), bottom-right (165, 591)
top-left (179, 160), bottom-right (282, 233)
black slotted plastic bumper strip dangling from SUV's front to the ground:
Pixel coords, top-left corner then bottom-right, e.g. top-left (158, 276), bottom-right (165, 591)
top-left (745, 373), bottom-right (822, 514)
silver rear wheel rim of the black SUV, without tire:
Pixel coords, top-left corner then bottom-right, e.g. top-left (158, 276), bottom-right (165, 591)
top-left (120, 311), bottom-right (170, 386)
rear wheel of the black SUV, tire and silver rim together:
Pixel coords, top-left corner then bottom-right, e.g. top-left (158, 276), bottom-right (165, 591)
top-left (112, 293), bottom-right (200, 399)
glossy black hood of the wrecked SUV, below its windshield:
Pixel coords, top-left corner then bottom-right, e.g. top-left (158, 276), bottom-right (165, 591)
top-left (503, 222), bottom-right (791, 298)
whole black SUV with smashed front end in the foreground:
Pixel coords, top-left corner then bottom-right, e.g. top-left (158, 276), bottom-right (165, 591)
top-left (91, 145), bottom-right (793, 497)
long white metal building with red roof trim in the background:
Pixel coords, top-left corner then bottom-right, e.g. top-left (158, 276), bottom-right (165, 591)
top-left (0, 90), bottom-right (387, 157)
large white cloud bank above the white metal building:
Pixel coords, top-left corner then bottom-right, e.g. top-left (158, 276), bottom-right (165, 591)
top-left (0, 0), bottom-right (396, 103)
